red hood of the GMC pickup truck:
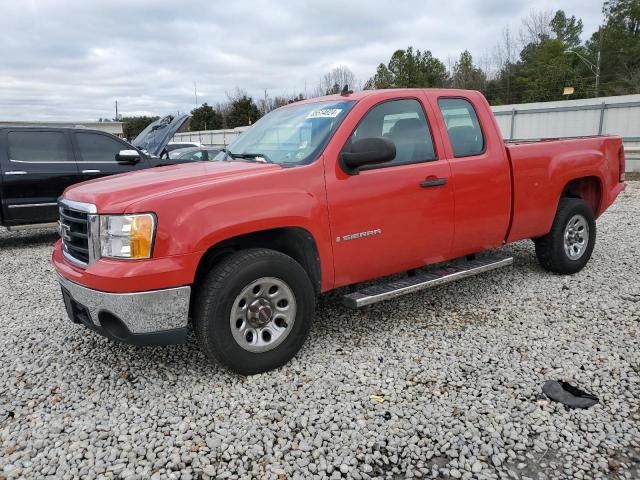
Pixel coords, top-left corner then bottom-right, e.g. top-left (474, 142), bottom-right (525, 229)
top-left (63, 161), bottom-right (281, 213)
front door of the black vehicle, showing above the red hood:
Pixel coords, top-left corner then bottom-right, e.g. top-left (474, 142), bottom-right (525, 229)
top-left (72, 130), bottom-right (149, 180)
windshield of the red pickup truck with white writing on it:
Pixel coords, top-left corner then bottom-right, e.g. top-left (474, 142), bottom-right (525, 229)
top-left (216, 100), bottom-right (355, 165)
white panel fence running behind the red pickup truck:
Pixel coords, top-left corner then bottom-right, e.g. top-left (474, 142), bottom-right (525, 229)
top-left (173, 95), bottom-right (640, 172)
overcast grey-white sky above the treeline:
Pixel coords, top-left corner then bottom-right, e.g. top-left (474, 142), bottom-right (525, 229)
top-left (0, 0), bottom-right (602, 121)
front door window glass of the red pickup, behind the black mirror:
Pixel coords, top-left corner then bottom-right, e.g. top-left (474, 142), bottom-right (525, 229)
top-left (345, 99), bottom-right (436, 169)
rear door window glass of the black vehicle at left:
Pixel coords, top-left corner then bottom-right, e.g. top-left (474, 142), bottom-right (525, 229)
top-left (7, 131), bottom-right (73, 163)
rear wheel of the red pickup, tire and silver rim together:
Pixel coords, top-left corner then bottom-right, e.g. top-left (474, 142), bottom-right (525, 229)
top-left (535, 197), bottom-right (596, 274)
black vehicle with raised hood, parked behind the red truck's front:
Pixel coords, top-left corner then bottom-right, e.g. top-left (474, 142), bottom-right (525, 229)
top-left (0, 115), bottom-right (193, 229)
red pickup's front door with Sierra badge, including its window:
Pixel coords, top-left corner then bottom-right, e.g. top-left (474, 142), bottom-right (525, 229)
top-left (326, 98), bottom-right (454, 286)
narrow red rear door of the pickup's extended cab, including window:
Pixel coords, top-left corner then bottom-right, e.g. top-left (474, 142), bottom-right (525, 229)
top-left (430, 94), bottom-right (511, 257)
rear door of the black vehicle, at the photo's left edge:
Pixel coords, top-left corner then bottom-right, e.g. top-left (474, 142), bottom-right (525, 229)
top-left (0, 128), bottom-right (81, 225)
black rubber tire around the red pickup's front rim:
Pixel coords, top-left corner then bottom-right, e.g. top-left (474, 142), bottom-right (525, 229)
top-left (193, 248), bottom-right (316, 375)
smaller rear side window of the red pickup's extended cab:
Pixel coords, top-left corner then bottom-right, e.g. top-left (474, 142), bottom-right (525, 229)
top-left (438, 98), bottom-right (484, 157)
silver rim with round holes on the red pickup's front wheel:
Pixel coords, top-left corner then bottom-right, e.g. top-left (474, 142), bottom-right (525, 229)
top-left (229, 277), bottom-right (296, 353)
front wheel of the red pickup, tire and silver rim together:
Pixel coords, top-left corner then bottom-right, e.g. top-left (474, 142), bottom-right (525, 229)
top-left (193, 249), bottom-right (315, 374)
